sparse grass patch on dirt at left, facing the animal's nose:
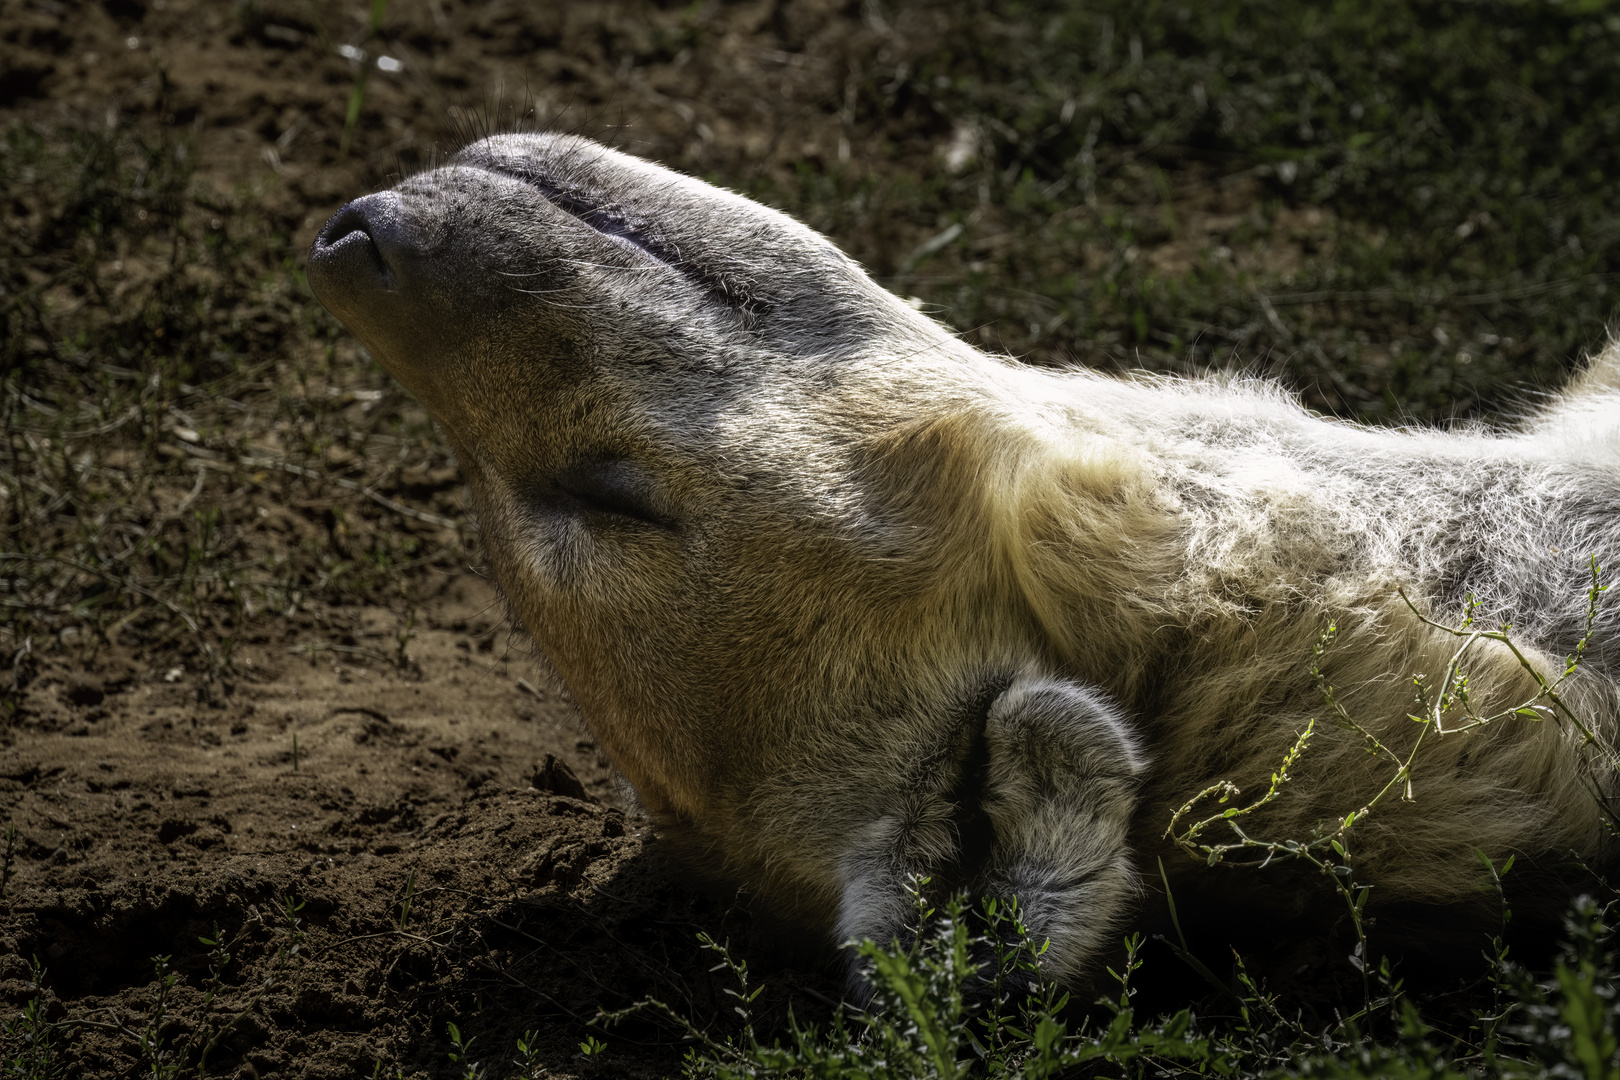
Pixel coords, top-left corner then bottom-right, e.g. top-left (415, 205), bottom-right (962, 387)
top-left (0, 111), bottom-right (463, 675)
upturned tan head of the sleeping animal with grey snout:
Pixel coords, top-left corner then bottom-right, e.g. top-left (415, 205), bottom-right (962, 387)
top-left (309, 134), bottom-right (1137, 984)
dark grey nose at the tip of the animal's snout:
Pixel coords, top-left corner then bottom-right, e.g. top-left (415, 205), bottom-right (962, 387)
top-left (306, 191), bottom-right (416, 306)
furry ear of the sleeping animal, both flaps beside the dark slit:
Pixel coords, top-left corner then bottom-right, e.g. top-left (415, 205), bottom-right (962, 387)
top-left (838, 675), bottom-right (1145, 1002)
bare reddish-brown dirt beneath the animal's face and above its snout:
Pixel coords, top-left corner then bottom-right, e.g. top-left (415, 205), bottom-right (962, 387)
top-left (0, 0), bottom-right (926, 1080)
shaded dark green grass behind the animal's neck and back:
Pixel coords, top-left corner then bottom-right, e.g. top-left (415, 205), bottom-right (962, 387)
top-left (752, 0), bottom-right (1620, 421)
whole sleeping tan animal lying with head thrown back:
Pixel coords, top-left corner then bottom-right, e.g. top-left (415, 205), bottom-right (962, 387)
top-left (308, 134), bottom-right (1620, 983)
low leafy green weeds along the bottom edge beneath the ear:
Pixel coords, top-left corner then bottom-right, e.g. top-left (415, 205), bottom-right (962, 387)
top-left (618, 897), bottom-right (1620, 1080)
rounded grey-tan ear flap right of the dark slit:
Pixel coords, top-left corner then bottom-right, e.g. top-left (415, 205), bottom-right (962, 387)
top-left (983, 677), bottom-right (1147, 983)
